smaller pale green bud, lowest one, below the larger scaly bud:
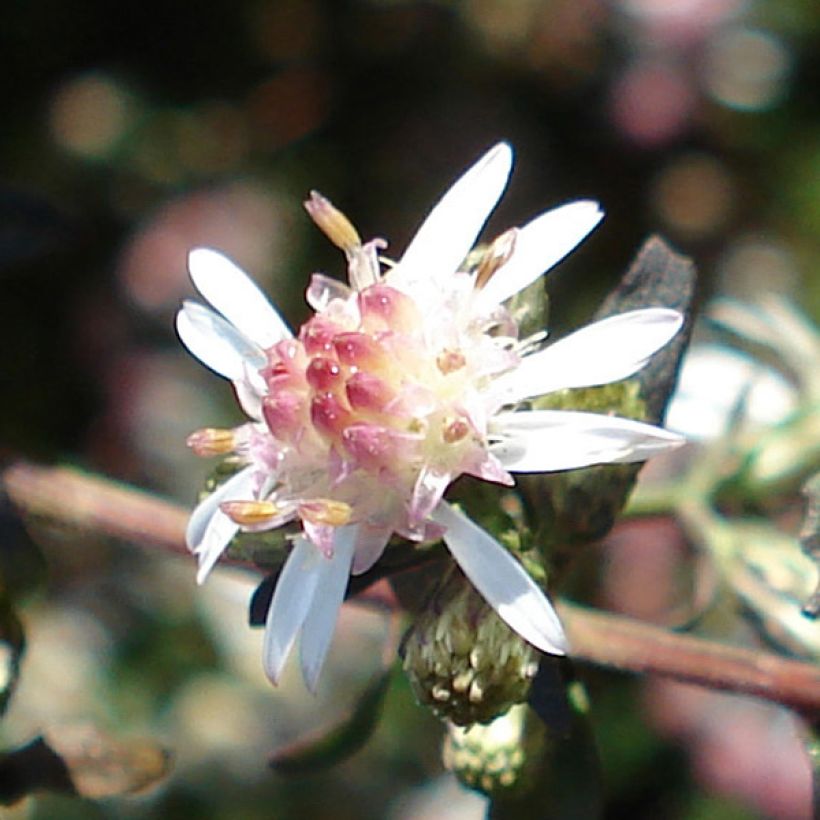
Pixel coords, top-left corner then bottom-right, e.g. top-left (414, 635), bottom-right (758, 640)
top-left (442, 704), bottom-right (547, 797)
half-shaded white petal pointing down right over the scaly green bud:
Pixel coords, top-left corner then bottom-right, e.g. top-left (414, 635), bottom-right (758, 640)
top-left (432, 502), bottom-right (568, 655)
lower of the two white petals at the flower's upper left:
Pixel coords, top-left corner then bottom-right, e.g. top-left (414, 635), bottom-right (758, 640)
top-left (176, 301), bottom-right (266, 380)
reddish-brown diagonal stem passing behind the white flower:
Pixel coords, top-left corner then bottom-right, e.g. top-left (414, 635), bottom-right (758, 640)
top-left (2, 463), bottom-right (820, 714)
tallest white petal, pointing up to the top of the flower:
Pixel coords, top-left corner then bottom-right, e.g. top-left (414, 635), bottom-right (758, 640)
top-left (387, 142), bottom-right (512, 286)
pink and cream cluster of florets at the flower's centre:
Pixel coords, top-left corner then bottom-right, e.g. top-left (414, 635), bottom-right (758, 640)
top-left (262, 283), bottom-right (483, 490)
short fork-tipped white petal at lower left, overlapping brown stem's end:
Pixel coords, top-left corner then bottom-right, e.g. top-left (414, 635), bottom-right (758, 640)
top-left (186, 467), bottom-right (256, 584)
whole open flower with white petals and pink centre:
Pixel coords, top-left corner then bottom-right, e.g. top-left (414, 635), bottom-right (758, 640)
top-left (177, 143), bottom-right (682, 689)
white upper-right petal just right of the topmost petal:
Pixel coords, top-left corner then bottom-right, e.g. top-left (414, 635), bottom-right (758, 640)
top-left (477, 200), bottom-right (604, 310)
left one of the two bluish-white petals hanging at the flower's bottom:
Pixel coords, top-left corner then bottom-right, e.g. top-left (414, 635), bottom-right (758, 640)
top-left (262, 536), bottom-right (326, 683)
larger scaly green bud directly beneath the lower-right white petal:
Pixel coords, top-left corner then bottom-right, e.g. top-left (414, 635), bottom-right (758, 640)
top-left (403, 570), bottom-right (538, 726)
